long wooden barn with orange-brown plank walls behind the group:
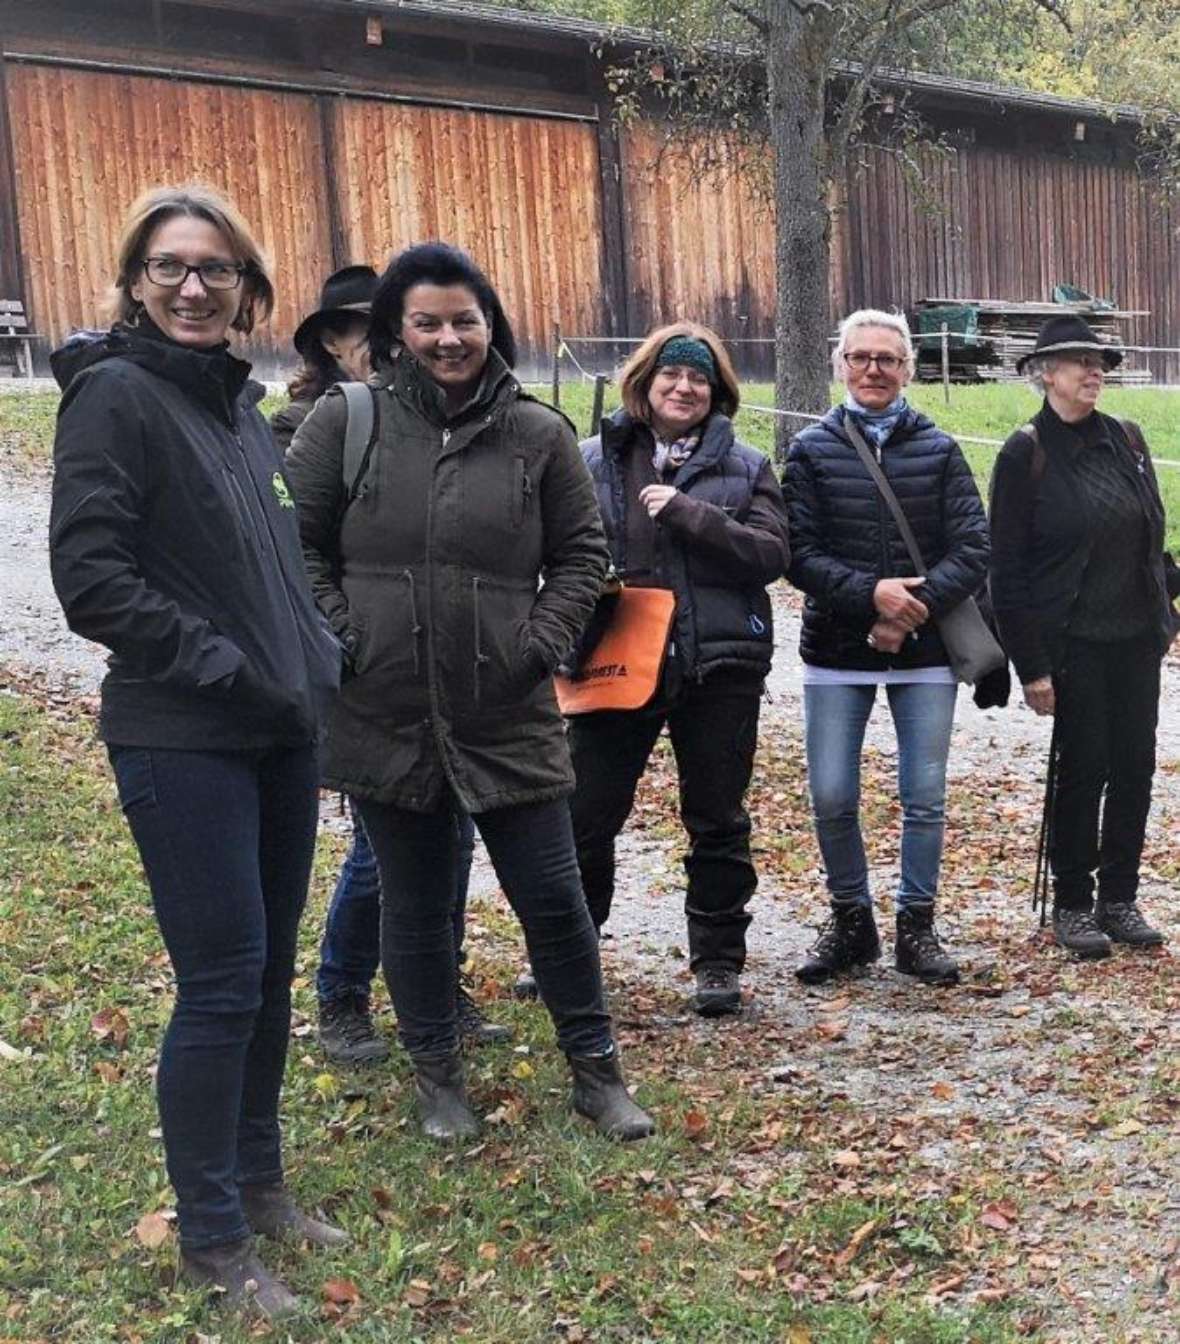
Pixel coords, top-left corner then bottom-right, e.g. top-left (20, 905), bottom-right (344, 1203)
top-left (0, 0), bottom-right (1180, 380)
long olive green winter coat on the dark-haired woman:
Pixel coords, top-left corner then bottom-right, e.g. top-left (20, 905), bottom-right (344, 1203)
top-left (286, 351), bottom-right (607, 813)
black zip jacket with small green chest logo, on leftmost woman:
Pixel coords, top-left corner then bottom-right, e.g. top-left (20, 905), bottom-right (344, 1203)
top-left (50, 327), bottom-right (340, 751)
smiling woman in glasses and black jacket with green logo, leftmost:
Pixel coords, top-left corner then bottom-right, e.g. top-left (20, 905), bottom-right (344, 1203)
top-left (50, 185), bottom-right (348, 1318)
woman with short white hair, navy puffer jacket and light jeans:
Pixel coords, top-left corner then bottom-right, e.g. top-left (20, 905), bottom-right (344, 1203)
top-left (785, 309), bottom-right (988, 985)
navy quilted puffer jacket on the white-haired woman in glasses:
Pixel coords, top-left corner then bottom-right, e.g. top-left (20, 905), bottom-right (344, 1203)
top-left (784, 406), bottom-right (989, 671)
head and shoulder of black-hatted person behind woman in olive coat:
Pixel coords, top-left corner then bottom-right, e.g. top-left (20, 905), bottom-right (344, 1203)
top-left (270, 266), bottom-right (376, 453)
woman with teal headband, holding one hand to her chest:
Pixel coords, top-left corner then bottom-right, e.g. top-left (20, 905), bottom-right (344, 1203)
top-left (570, 323), bottom-right (789, 1016)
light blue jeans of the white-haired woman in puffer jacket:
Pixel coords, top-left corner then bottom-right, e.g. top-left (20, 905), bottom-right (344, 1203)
top-left (804, 681), bottom-right (958, 910)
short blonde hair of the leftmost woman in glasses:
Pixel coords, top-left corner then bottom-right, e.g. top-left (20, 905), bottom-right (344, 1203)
top-left (106, 181), bottom-right (274, 336)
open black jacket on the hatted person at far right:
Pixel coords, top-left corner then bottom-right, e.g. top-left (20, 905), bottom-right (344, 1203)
top-left (991, 402), bottom-right (1180, 685)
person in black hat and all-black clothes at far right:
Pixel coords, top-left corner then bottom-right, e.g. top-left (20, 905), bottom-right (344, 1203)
top-left (991, 316), bottom-right (1180, 958)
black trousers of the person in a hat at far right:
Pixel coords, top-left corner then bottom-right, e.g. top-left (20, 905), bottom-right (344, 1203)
top-left (1050, 636), bottom-right (1160, 909)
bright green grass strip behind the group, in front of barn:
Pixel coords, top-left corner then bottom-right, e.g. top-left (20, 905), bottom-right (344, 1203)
top-left (0, 380), bottom-right (1180, 554)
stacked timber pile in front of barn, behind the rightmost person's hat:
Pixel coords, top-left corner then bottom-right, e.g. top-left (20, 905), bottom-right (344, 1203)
top-left (913, 298), bottom-right (1152, 384)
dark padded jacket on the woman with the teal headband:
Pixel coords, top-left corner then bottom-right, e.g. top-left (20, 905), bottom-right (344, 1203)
top-left (582, 410), bottom-right (790, 680)
